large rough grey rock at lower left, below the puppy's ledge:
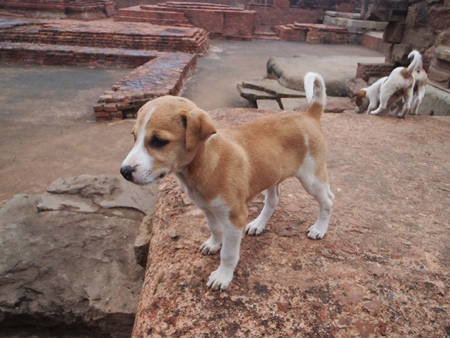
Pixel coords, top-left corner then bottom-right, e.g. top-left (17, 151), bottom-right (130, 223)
top-left (0, 175), bottom-right (154, 338)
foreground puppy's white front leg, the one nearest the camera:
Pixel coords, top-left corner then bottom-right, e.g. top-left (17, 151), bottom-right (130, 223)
top-left (206, 213), bottom-right (243, 290)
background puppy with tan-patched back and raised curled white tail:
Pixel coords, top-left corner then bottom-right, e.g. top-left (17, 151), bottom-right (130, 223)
top-left (370, 50), bottom-right (422, 118)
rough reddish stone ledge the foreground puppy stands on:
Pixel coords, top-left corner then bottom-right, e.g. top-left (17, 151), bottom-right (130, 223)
top-left (133, 109), bottom-right (450, 338)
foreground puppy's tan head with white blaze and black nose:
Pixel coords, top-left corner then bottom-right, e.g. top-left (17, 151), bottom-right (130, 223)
top-left (120, 96), bottom-right (216, 184)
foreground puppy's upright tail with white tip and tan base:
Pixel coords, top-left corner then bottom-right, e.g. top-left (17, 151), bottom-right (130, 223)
top-left (303, 72), bottom-right (327, 120)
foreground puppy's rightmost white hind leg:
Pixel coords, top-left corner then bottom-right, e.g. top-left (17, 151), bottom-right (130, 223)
top-left (296, 160), bottom-right (334, 239)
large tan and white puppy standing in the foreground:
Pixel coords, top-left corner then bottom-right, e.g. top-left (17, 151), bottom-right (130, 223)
top-left (120, 73), bottom-right (334, 290)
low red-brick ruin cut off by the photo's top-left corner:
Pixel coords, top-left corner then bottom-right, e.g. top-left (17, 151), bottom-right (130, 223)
top-left (0, 0), bottom-right (114, 20)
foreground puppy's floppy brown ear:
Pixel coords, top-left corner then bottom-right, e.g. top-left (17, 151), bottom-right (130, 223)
top-left (181, 108), bottom-right (216, 151)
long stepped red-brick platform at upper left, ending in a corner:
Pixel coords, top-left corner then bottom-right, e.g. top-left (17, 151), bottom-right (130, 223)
top-left (0, 21), bottom-right (209, 54)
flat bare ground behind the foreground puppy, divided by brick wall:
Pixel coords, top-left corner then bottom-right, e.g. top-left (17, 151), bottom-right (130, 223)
top-left (0, 41), bottom-right (384, 206)
